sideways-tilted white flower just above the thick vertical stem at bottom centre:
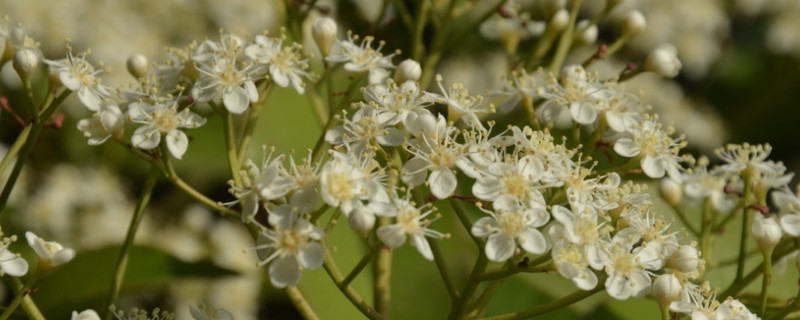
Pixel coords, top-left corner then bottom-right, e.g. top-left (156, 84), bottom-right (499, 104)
top-left (369, 197), bottom-right (447, 260)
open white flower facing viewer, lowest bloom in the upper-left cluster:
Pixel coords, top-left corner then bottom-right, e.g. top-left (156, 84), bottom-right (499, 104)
top-left (128, 99), bottom-right (206, 159)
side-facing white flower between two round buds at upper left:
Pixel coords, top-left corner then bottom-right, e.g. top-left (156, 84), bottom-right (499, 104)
top-left (45, 48), bottom-right (109, 111)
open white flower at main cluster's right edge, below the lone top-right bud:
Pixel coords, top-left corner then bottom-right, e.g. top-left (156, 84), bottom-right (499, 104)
top-left (614, 119), bottom-right (686, 182)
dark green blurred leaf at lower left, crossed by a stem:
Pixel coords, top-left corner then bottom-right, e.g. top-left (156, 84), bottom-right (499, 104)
top-left (32, 246), bottom-right (236, 319)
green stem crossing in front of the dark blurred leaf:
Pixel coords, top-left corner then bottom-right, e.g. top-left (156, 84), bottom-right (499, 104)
top-left (105, 166), bottom-right (159, 320)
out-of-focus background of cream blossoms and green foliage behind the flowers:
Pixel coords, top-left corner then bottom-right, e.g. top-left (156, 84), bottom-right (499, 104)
top-left (0, 0), bottom-right (800, 319)
